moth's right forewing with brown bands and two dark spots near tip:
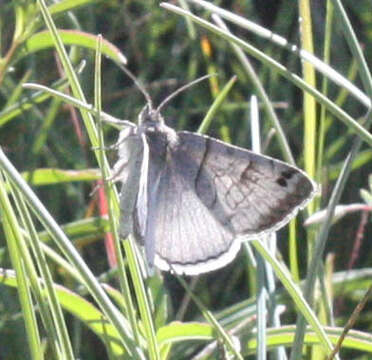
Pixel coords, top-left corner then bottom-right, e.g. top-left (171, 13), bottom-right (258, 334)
top-left (179, 132), bottom-right (316, 238)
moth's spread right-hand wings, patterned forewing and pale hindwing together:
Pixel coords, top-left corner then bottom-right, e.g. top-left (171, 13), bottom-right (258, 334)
top-left (145, 132), bottom-right (315, 275)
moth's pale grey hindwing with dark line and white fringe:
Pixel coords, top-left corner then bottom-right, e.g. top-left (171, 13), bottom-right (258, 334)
top-left (144, 136), bottom-right (240, 275)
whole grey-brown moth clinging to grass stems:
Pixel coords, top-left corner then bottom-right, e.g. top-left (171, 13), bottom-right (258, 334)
top-left (114, 74), bottom-right (316, 275)
